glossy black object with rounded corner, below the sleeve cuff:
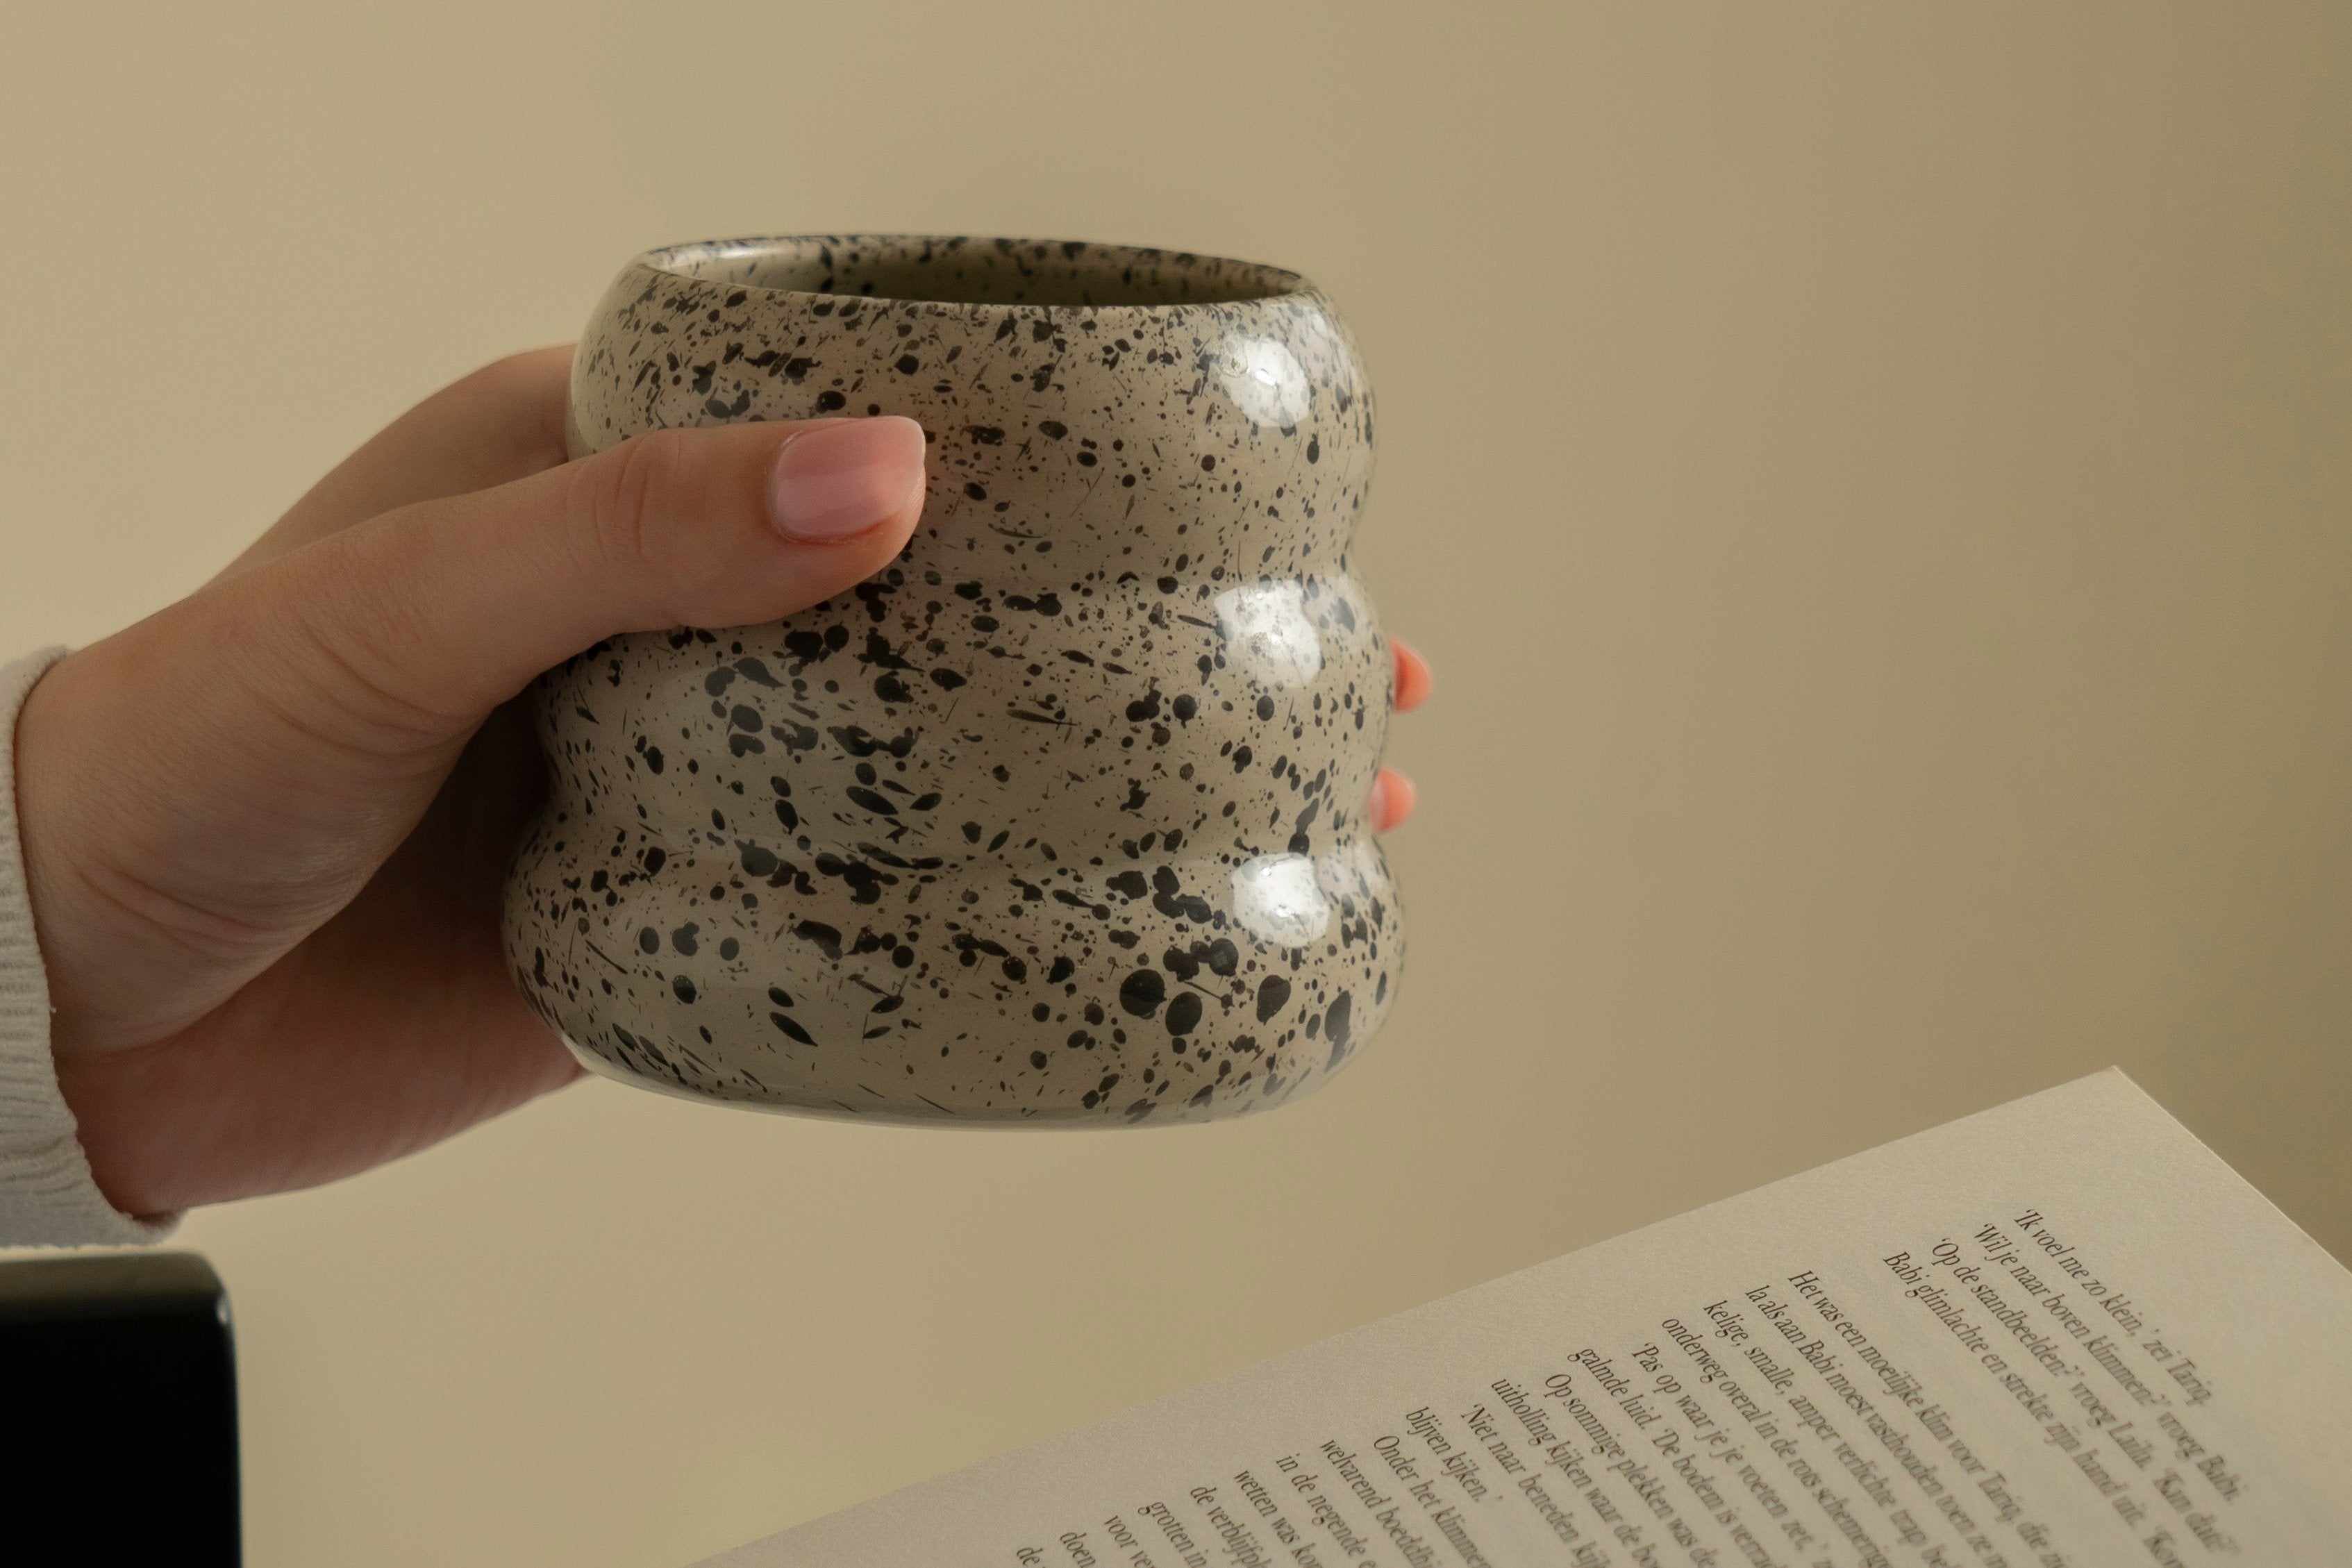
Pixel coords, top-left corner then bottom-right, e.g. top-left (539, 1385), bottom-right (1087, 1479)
top-left (0, 1253), bottom-right (242, 1568)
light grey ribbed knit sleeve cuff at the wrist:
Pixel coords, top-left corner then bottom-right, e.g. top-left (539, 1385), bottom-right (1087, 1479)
top-left (0, 649), bottom-right (178, 1246)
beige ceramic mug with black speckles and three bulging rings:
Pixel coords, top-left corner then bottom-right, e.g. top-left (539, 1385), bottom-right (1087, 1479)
top-left (506, 235), bottom-right (1402, 1126)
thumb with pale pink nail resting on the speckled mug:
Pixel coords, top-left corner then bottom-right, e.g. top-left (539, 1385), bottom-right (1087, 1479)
top-left (254, 416), bottom-right (924, 750)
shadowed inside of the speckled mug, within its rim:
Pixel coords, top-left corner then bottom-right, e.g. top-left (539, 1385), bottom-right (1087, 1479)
top-left (644, 235), bottom-right (1306, 308)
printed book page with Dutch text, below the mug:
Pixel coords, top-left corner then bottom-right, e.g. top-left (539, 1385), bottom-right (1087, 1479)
top-left (706, 1069), bottom-right (2352, 1568)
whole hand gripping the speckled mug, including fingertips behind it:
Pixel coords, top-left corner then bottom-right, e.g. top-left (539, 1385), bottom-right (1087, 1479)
top-left (17, 348), bottom-right (1428, 1213)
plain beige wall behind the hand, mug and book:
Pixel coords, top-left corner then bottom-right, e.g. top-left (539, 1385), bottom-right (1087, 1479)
top-left (0, 0), bottom-right (2352, 1568)
